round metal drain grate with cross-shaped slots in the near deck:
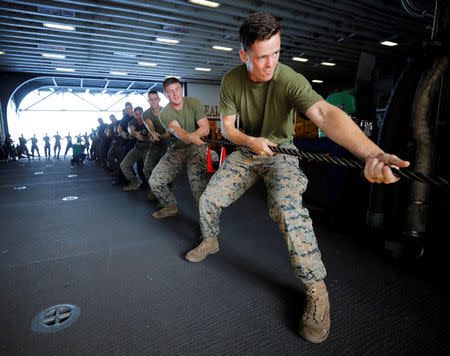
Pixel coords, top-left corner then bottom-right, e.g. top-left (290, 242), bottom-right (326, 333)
top-left (31, 304), bottom-right (80, 333)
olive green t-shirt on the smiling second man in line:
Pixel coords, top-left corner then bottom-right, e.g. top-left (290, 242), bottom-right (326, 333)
top-left (159, 97), bottom-right (206, 148)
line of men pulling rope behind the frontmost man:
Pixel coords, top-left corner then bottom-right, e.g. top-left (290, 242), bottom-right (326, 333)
top-left (92, 84), bottom-right (209, 219)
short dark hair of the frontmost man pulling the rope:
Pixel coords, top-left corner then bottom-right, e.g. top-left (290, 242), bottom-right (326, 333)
top-left (239, 12), bottom-right (281, 51)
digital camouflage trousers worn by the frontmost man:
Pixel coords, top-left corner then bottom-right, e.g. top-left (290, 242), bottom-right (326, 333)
top-left (199, 144), bottom-right (326, 284)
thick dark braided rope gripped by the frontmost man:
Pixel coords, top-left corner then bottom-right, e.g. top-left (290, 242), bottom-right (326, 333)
top-left (203, 139), bottom-right (450, 188)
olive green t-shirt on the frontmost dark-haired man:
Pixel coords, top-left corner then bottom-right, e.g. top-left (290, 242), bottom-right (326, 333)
top-left (219, 63), bottom-right (323, 144)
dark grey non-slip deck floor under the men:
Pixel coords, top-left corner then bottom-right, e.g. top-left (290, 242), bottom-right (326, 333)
top-left (0, 159), bottom-right (449, 355)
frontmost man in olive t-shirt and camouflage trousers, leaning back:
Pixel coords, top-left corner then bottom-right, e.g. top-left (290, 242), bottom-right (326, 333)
top-left (186, 13), bottom-right (409, 343)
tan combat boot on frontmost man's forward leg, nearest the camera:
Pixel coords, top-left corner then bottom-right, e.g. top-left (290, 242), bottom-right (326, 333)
top-left (299, 281), bottom-right (330, 344)
